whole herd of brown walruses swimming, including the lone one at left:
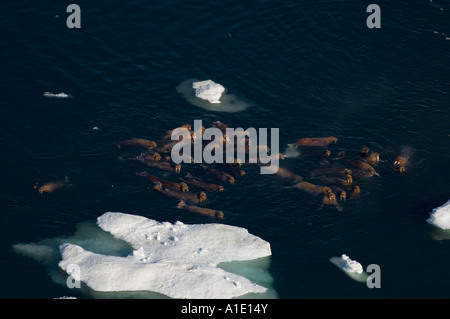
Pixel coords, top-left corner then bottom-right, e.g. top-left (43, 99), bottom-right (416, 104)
top-left (34, 121), bottom-right (409, 218)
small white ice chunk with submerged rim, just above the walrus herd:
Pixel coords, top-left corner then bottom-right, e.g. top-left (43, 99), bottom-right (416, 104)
top-left (176, 79), bottom-right (249, 112)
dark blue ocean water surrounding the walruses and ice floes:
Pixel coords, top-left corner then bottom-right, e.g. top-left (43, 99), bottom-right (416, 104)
top-left (0, 0), bottom-right (450, 298)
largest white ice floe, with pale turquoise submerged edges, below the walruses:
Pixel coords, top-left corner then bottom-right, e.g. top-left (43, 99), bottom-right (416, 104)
top-left (14, 212), bottom-right (276, 299)
